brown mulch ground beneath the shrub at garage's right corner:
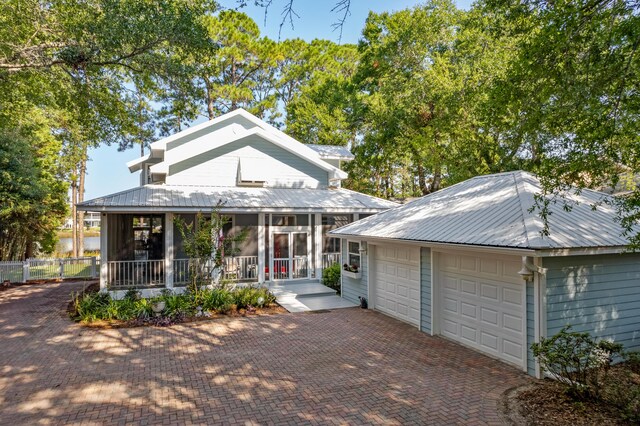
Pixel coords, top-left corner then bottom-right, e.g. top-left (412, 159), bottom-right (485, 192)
top-left (503, 365), bottom-right (635, 426)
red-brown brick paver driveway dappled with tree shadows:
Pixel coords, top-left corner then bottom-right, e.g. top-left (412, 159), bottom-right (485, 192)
top-left (0, 283), bottom-right (528, 425)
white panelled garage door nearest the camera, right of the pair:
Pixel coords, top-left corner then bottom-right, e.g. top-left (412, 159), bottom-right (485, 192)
top-left (438, 253), bottom-right (526, 367)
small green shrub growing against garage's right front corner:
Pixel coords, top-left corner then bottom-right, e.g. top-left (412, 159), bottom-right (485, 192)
top-left (531, 326), bottom-right (622, 400)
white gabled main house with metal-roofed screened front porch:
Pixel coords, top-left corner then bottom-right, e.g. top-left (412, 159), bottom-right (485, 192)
top-left (78, 109), bottom-right (397, 294)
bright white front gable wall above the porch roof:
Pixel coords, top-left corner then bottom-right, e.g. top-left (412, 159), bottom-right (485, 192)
top-left (166, 135), bottom-right (329, 188)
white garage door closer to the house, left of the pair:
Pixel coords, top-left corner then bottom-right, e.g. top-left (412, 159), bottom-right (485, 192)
top-left (373, 245), bottom-right (420, 326)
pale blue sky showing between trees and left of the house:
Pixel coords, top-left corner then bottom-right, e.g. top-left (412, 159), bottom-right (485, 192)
top-left (85, 0), bottom-right (472, 200)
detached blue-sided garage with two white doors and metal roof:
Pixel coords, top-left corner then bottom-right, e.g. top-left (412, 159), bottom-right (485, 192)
top-left (332, 172), bottom-right (640, 375)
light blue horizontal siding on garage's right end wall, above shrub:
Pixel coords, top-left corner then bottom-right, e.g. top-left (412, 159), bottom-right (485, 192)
top-left (543, 254), bottom-right (640, 349)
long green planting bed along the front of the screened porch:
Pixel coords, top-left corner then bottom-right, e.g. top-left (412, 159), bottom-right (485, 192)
top-left (67, 285), bottom-right (287, 328)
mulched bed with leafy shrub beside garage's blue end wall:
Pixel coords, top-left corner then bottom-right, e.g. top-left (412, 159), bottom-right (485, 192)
top-left (503, 327), bottom-right (640, 426)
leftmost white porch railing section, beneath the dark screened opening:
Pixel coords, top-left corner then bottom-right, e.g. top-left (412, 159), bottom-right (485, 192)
top-left (107, 259), bottom-right (165, 290)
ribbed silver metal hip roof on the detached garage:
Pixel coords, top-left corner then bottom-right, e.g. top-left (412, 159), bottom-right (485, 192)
top-left (332, 171), bottom-right (628, 249)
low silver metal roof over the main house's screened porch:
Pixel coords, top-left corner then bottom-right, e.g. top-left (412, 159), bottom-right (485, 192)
top-left (78, 185), bottom-right (398, 212)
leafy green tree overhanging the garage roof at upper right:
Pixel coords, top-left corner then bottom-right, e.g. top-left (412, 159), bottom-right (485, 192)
top-left (478, 0), bottom-right (640, 240)
